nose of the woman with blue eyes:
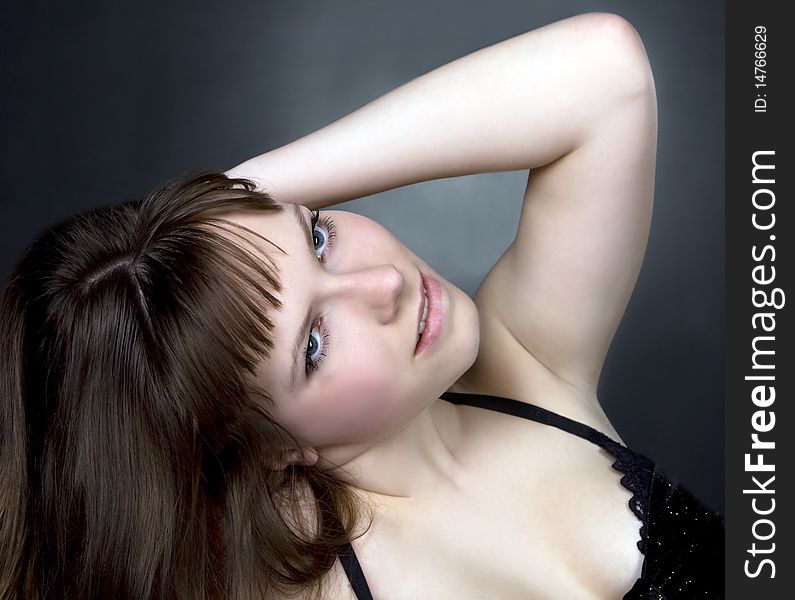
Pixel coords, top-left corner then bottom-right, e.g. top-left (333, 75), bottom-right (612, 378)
top-left (327, 264), bottom-right (405, 323)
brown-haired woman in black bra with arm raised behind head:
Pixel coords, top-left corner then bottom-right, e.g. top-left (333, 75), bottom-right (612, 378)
top-left (0, 13), bottom-right (723, 600)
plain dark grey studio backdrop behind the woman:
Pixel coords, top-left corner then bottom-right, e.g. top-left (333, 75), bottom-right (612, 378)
top-left (0, 0), bottom-right (724, 511)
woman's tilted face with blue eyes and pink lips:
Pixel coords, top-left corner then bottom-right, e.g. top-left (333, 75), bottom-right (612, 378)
top-left (227, 204), bottom-right (479, 464)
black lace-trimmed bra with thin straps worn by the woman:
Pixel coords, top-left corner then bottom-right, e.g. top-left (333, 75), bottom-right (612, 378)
top-left (332, 392), bottom-right (724, 600)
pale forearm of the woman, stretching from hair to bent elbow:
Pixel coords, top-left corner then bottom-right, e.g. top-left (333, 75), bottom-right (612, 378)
top-left (224, 13), bottom-right (650, 208)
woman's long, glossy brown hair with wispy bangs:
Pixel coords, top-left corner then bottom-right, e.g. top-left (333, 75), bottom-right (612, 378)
top-left (0, 171), bottom-right (374, 600)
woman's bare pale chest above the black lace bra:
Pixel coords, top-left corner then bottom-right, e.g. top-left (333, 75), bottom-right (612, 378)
top-left (353, 411), bottom-right (643, 600)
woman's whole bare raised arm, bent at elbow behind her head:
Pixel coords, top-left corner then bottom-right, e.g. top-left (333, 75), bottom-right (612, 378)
top-left (231, 13), bottom-right (657, 403)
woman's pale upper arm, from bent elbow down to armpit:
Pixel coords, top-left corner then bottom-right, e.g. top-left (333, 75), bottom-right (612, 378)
top-left (475, 15), bottom-right (657, 397)
